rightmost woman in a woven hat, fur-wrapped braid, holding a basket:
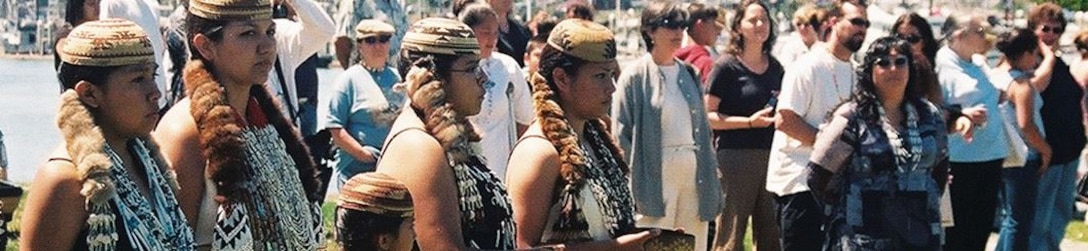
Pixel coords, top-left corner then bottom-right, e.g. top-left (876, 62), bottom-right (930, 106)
top-left (506, 20), bottom-right (657, 250)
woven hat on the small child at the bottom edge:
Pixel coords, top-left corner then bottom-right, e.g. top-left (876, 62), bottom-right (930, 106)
top-left (336, 172), bottom-right (412, 217)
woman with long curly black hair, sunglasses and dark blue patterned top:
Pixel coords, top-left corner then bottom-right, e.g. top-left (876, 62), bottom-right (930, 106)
top-left (808, 37), bottom-right (949, 250)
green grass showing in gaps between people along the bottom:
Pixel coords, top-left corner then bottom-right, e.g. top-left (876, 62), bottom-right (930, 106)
top-left (4, 191), bottom-right (1088, 250)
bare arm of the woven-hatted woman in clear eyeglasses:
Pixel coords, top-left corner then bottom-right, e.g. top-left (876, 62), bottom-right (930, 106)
top-left (378, 130), bottom-right (468, 250)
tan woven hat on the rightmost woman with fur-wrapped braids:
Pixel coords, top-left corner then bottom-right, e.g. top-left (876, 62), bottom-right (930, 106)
top-left (547, 18), bottom-right (616, 63)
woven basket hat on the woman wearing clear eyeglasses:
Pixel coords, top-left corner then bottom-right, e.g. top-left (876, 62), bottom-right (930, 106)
top-left (400, 17), bottom-right (480, 55)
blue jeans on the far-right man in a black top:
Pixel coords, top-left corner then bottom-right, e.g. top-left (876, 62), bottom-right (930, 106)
top-left (1029, 160), bottom-right (1080, 250)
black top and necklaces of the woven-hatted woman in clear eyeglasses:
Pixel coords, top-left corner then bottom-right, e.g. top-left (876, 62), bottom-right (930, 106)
top-left (386, 127), bottom-right (515, 250)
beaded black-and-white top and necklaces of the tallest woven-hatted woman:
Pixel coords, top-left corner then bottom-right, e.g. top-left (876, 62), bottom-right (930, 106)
top-left (198, 99), bottom-right (324, 250)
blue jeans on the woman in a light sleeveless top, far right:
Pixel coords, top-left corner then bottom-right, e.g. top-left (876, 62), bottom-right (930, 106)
top-left (996, 154), bottom-right (1042, 250)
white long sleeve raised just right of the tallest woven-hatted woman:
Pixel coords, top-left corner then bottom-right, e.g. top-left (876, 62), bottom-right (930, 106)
top-left (265, 0), bottom-right (336, 125)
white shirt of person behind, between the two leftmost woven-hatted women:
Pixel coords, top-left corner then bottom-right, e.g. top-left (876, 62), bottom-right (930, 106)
top-left (98, 0), bottom-right (170, 108)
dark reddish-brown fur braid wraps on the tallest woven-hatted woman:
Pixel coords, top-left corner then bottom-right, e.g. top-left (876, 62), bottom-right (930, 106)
top-left (184, 60), bottom-right (323, 203)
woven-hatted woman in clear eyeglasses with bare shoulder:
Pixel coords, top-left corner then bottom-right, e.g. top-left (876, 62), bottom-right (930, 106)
top-left (378, 18), bottom-right (514, 250)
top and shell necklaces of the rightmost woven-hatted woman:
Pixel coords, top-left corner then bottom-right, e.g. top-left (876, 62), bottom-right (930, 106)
top-left (529, 123), bottom-right (634, 243)
